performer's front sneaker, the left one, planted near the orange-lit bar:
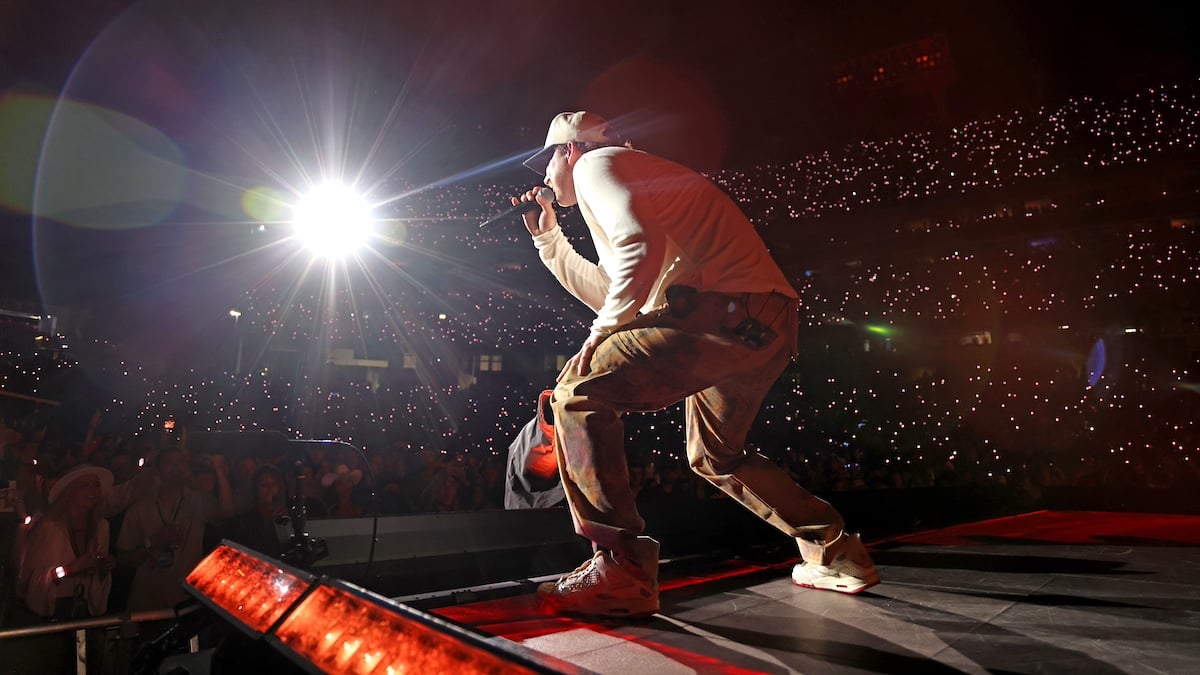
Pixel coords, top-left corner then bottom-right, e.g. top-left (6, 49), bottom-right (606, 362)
top-left (538, 550), bottom-right (659, 617)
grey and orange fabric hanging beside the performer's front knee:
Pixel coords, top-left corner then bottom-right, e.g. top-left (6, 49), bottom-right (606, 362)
top-left (504, 389), bottom-right (565, 509)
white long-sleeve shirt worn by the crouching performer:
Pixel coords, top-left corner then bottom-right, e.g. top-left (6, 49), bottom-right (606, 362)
top-left (534, 148), bottom-right (797, 335)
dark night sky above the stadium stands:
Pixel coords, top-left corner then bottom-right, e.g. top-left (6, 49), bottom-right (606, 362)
top-left (0, 0), bottom-right (1200, 326)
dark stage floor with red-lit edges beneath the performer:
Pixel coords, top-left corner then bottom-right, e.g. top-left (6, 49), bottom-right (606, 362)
top-left (433, 510), bottom-right (1200, 675)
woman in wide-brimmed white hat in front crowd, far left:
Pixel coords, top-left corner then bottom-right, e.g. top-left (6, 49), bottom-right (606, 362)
top-left (17, 465), bottom-right (116, 619)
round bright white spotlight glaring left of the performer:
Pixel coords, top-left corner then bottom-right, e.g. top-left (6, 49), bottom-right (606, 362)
top-left (292, 183), bottom-right (374, 258)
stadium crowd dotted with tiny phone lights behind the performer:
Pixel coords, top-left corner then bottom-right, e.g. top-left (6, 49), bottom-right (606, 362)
top-left (0, 82), bottom-right (1200, 617)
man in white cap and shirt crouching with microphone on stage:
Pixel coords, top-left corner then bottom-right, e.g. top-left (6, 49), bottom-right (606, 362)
top-left (521, 112), bottom-right (878, 616)
